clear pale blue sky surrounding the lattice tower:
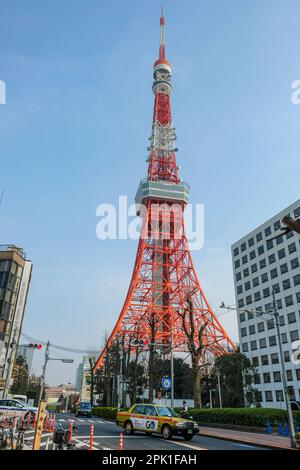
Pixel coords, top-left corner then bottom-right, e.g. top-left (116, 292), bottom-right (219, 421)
top-left (0, 0), bottom-right (300, 384)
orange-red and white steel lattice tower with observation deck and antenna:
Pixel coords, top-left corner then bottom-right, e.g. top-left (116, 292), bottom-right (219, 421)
top-left (95, 15), bottom-right (236, 369)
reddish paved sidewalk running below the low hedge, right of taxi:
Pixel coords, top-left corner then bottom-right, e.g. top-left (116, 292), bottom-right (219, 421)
top-left (199, 425), bottom-right (291, 450)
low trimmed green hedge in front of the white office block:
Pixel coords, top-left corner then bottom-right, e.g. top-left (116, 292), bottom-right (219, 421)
top-left (185, 408), bottom-right (300, 427)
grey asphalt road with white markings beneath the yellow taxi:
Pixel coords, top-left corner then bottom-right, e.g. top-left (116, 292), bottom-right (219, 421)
top-left (25, 414), bottom-right (268, 451)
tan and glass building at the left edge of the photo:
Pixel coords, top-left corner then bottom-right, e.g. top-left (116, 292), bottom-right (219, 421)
top-left (0, 245), bottom-right (32, 396)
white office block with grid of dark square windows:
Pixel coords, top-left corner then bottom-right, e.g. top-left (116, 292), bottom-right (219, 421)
top-left (231, 200), bottom-right (300, 408)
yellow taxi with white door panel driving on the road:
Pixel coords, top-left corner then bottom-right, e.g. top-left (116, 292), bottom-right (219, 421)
top-left (116, 403), bottom-right (199, 441)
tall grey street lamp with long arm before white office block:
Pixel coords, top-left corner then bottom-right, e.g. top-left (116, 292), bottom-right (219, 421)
top-left (220, 289), bottom-right (296, 448)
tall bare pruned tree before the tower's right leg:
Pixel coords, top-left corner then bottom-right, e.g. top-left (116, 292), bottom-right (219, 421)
top-left (178, 292), bottom-right (208, 408)
